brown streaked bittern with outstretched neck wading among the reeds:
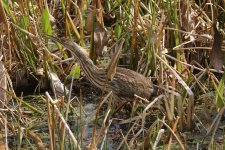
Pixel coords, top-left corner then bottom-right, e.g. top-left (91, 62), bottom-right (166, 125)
top-left (50, 36), bottom-right (153, 101)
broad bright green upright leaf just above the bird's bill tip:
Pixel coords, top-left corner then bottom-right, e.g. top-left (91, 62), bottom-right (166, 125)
top-left (41, 9), bottom-right (52, 35)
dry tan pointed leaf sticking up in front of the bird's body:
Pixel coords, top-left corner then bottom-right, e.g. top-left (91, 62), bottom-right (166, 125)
top-left (106, 38), bottom-right (125, 81)
